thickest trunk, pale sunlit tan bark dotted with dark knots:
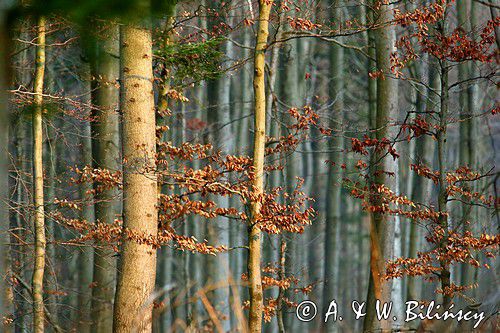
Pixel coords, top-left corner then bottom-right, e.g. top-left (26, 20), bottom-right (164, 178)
top-left (113, 11), bottom-right (158, 333)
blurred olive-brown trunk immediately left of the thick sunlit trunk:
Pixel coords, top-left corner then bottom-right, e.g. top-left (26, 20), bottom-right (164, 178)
top-left (89, 22), bottom-right (121, 333)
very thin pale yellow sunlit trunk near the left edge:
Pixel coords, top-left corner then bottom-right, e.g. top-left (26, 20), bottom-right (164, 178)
top-left (32, 16), bottom-right (46, 333)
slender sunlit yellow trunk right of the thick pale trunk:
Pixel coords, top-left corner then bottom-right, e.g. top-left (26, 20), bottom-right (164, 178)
top-left (248, 0), bottom-right (273, 333)
